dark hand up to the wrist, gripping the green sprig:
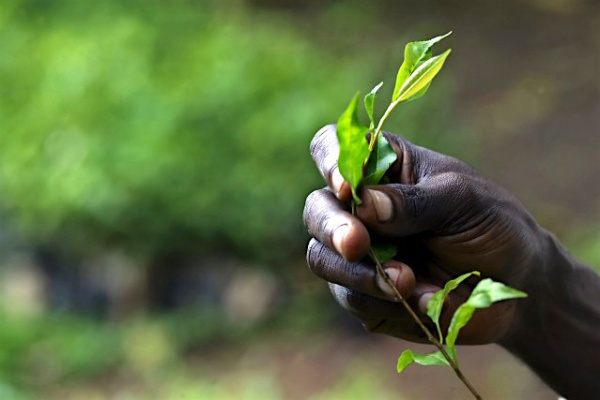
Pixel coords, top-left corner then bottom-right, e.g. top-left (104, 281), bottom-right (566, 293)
top-left (304, 126), bottom-right (544, 344)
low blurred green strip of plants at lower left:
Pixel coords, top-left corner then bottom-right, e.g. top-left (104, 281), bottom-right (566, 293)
top-left (0, 290), bottom-right (332, 399)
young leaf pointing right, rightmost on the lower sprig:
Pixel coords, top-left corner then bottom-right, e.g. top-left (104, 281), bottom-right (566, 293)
top-left (446, 278), bottom-right (527, 361)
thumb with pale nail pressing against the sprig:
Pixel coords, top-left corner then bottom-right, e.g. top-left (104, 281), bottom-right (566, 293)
top-left (356, 174), bottom-right (471, 237)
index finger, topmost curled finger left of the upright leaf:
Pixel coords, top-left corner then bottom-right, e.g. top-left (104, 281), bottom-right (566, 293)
top-left (310, 124), bottom-right (352, 201)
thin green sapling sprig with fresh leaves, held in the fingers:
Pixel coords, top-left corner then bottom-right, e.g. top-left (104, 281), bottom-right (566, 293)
top-left (336, 32), bottom-right (527, 399)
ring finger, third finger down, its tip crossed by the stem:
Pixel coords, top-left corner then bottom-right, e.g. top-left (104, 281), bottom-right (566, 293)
top-left (306, 239), bottom-right (415, 300)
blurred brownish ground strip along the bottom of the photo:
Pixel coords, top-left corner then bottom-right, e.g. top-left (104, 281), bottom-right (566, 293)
top-left (0, 320), bottom-right (557, 400)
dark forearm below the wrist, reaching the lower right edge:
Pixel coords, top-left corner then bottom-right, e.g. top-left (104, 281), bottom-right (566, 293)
top-left (501, 234), bottom-right (600, 400)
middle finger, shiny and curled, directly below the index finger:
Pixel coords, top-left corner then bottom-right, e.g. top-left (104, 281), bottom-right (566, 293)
top-left (304, 189), bottom-right (371, 261)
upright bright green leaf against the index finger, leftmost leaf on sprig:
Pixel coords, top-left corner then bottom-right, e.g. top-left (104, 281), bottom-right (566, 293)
top-left (336, 93), bottom-right (369, 204)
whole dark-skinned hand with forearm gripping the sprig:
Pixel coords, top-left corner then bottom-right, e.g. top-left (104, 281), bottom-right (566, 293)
top-left (304, 125), bottom-right (600, 399)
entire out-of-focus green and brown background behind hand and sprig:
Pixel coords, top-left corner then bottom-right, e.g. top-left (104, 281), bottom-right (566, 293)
top-left (0, 0), bottom-right (600, 400)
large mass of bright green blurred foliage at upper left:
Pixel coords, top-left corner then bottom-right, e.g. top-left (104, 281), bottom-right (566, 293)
top-left (0, 0), bottom-right (460, 260)
